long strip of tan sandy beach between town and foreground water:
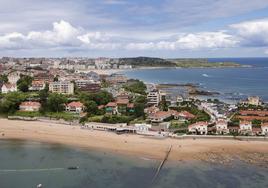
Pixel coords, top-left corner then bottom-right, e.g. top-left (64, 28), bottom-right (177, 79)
top-left (0, 119), bottom-right (268, 163)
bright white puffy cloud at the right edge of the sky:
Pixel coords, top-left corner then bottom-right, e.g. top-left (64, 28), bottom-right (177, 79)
top-left (231, 19), bottom-right (268, 46)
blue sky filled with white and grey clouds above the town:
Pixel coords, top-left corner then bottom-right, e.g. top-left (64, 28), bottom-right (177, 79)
top-left (0, 0), bottom-right (268, 58)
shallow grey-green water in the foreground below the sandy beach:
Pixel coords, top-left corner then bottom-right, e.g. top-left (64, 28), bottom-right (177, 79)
top-left (0, 140), bottom-right (268, 188)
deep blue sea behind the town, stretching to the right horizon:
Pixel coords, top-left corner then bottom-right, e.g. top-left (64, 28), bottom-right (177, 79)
top-left (124, 58), bottom-right (268, 103)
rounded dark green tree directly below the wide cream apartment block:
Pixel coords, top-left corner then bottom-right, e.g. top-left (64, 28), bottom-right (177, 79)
top-left (47, 93), bottom-right (67, 112)
